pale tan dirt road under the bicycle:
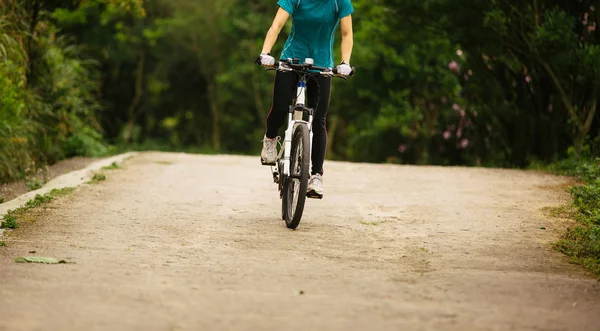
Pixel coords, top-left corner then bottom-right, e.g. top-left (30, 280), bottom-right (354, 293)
top-left (0, 153), bottom-right (600, 331)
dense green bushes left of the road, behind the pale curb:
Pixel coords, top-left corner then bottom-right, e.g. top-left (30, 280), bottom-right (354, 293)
top-left (0, 0), bottom-right (106, 182)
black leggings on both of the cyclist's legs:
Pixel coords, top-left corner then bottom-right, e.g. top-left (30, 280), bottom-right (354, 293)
top-left (267, 71), bottom-right (331, 175)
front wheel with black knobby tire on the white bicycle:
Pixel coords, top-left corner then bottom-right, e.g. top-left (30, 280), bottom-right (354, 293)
top-left (282, 124), bottom-right (310, 229)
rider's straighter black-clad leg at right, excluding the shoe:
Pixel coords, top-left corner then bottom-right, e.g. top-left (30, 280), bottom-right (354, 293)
top-left (306, 75), bottom-right (331, 175)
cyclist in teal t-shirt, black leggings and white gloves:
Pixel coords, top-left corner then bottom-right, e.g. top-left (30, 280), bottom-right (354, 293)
top-left (257, 0), bottom-right (354, 198)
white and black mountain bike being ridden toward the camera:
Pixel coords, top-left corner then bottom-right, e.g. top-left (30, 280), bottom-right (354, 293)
top-left (263, 58), bottom-right (354, 229)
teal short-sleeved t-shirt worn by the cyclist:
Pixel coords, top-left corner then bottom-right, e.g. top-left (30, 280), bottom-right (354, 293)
top-left (277, 0), bottom-right (354, 68)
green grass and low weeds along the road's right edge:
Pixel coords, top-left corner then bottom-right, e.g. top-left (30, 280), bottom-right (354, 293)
top-left (548, 158), bottom-right (600, 276)
